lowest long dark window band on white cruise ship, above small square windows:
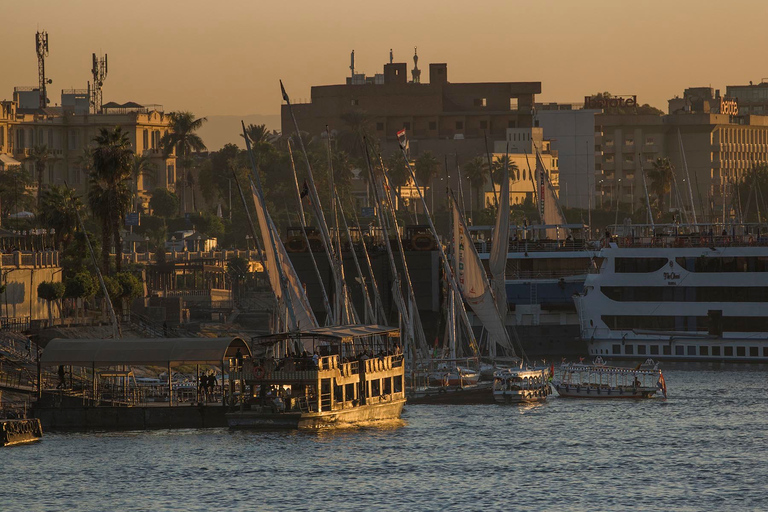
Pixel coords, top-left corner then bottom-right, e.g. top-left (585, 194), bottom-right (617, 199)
top-left (600, 312), bottom-right (768, 334)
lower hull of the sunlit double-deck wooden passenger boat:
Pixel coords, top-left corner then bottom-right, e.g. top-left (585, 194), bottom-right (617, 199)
top-left (226, 399), bottom-right (405, 430)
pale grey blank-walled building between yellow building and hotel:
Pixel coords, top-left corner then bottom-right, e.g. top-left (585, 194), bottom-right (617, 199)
top-left (536, 103), bottom-right (602, 209)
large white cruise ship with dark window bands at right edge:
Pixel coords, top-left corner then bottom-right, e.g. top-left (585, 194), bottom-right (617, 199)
top-left (575, 225), bottom-right (768, 362)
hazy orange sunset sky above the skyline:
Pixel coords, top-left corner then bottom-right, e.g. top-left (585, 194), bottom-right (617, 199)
top-left (6, 0), bottom-right (768, 115)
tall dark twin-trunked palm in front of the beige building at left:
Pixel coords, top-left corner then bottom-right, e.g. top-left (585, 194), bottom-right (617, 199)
top-left (88, 126), bottom-right (133, 272)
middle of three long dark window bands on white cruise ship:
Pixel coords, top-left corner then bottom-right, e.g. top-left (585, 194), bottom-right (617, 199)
top-left (600, 286), bottom-right (768, 302)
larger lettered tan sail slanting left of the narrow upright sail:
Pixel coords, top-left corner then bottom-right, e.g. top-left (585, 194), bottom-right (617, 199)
top-left (451, 195), bottom-right (515, 356)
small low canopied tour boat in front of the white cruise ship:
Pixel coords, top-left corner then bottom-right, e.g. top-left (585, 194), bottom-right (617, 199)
top-left (552, 357), bottom-right (667, 398)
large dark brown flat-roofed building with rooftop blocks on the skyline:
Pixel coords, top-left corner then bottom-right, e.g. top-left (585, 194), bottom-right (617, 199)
top-left (282, 55), bottom-right (541, 161)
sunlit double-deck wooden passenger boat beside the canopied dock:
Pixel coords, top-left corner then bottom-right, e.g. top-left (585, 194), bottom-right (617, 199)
top-left (227, 325), bottom-right (405, 429)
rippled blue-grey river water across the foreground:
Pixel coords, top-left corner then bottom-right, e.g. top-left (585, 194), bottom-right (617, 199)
top-left (0, 368), bottom-right (768, 512)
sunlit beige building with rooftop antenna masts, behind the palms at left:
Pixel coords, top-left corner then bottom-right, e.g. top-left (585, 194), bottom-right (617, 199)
top-left (0, 90), bottom-right (176, 206)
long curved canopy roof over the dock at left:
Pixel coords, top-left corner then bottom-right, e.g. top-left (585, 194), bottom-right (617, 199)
top-left (40, 338), bottom-right (251, 367)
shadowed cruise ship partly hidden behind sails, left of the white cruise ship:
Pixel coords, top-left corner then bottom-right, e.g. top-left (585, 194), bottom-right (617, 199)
top-left (469, 224), bottom-right (599, 358)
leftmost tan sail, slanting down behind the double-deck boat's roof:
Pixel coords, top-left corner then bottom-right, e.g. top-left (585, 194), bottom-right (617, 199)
top-left (251, 182), bottom-right (320, 330)
